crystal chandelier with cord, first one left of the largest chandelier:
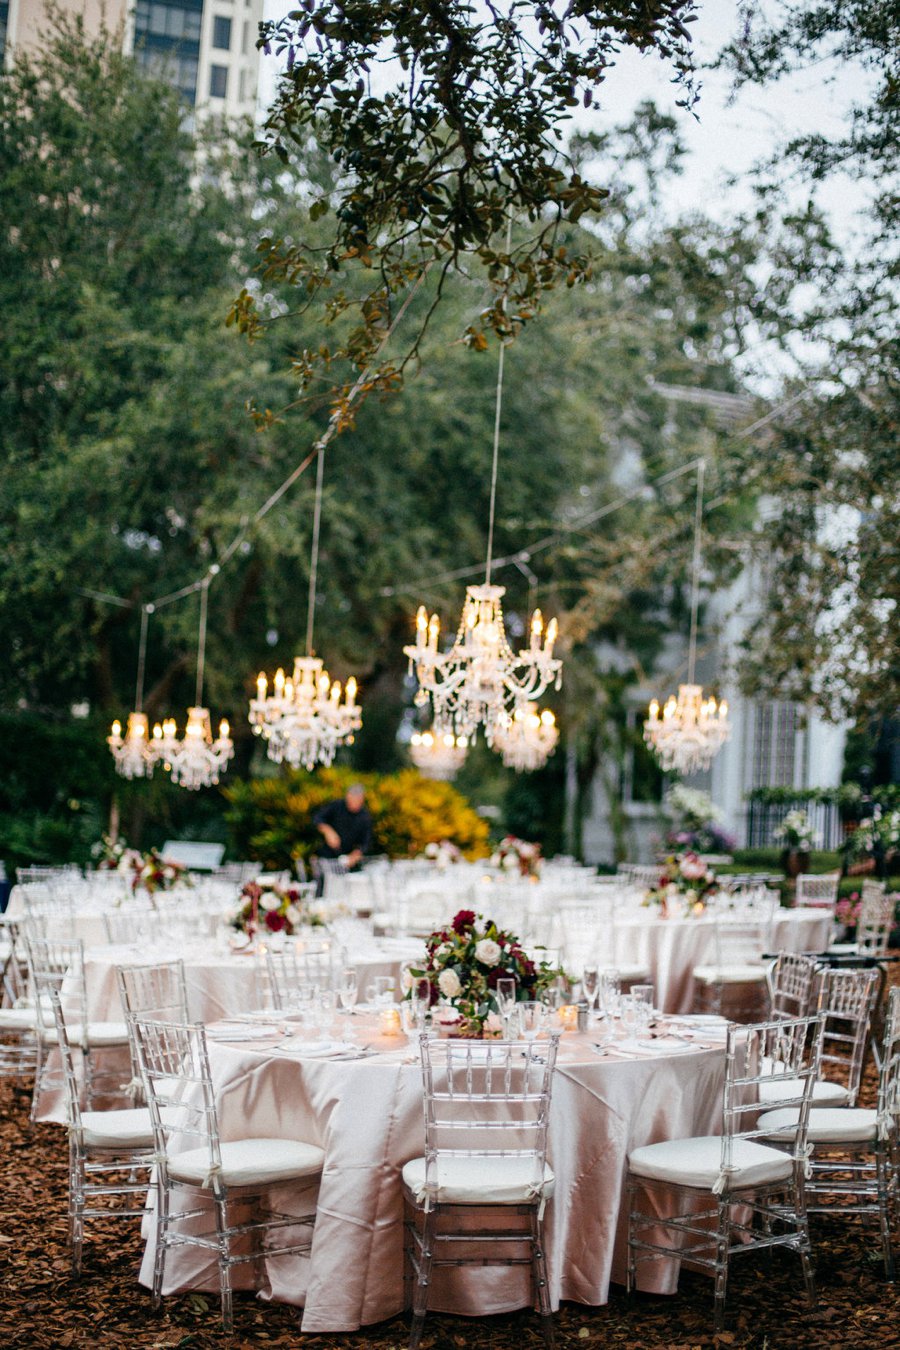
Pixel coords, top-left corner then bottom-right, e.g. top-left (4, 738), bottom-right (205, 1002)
top-left (250, 444), bottom-right (363, 771)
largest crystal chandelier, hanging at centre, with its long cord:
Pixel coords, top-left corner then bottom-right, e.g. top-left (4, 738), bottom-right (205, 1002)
top-left (403, 256), bottom-right (563, 745)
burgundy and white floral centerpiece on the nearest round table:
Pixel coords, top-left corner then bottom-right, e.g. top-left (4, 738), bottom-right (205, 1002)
top-left (405, 910), bottom-right (564, 1037)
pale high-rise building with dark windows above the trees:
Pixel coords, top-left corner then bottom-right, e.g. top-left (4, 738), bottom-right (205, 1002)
top-left (0, 0), bottom-right (263, 117)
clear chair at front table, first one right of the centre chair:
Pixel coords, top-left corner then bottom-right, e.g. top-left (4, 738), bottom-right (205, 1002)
top-left (627, 1018), bottom-right (822, 1331)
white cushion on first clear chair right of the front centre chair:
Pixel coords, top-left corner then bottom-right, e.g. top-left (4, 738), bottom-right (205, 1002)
top-left (629, 1134), bottom-right (793, 1191)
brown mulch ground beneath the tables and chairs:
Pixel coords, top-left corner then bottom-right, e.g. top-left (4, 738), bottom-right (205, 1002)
top-left (0, 999), bottom-right (900, 1350)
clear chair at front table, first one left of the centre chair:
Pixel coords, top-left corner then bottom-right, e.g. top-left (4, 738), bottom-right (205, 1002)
top-left (131, 1017), bottom-right (325, 1332)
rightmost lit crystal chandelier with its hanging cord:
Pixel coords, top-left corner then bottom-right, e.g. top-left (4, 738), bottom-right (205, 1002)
top-left (644, 460), bottom-right (731, 774)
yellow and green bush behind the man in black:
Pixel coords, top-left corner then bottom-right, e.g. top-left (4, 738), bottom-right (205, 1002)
top-left (225, 768), bottom-right (487, 871)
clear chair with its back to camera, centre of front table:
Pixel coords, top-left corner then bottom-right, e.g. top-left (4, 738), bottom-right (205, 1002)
top-left (402, 1034), bottom-right (559, 1350)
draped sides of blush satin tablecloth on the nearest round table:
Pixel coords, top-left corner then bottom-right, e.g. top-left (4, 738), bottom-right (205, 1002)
top-left (140, 1018), bottom-right (725, 1332)
